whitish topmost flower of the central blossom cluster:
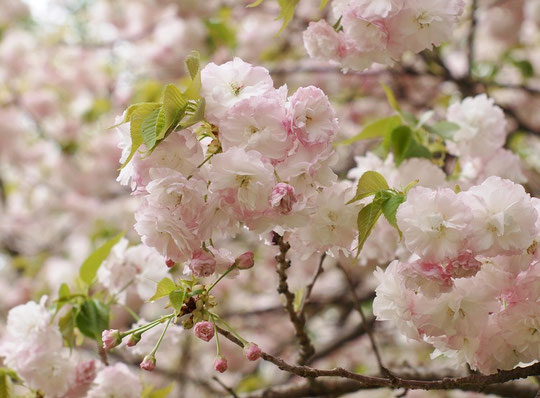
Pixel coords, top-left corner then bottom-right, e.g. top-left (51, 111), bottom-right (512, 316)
top-left (201, 58), bottom-right (274, 124)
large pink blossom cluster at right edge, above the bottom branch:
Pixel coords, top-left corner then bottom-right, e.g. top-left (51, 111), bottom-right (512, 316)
top-left (374, 176), bottom-right (540, 373)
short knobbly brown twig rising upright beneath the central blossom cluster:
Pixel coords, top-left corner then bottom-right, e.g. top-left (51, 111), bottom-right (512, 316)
top-left (273, 232), bottom-right (315, 364)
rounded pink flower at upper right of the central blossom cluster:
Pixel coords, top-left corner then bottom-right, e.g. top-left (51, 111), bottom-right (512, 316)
top-left (288, 86), bottom-right (338, 146)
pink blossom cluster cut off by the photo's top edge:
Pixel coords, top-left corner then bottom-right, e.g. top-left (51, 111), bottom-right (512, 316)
top-left (304, 0), bottom-right (465, 70)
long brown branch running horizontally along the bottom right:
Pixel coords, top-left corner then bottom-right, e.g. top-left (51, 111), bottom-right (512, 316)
top-left (217, 327), bottom-right (540, 391)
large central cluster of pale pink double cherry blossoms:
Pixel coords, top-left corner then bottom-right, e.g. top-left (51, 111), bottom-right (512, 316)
top-left (119, 58), bottom-right (358, 277)
